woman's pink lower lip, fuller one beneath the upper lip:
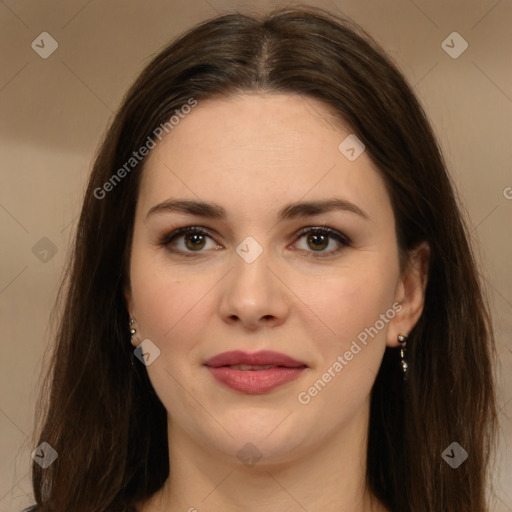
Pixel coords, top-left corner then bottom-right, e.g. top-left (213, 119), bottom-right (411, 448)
top-left (208, 366), bottom-right (306, 395)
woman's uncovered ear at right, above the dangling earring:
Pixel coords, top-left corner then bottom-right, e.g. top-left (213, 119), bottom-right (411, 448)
top-left (387, 242), bottom-right (430, 347)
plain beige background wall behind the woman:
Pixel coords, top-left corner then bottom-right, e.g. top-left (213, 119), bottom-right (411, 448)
top-left (0, 0), bottom-right (512, 512)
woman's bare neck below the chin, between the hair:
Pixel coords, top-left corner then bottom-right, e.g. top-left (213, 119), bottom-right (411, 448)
top-left (141, 404), bottom-right (387, 512)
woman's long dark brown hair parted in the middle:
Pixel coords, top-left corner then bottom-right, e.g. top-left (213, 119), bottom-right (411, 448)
top-left (23, 6), bottom-right (497, 512)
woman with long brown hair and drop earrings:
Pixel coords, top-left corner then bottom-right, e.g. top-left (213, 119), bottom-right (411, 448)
top-left (23, 8), bottom-right (496, 512)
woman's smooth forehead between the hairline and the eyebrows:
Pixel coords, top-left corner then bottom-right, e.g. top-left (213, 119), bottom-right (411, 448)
top-left (139, 93), bottom-right (389, 224)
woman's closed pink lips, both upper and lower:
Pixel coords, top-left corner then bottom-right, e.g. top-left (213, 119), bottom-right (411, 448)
top-left (204, 350), bottom-right (307, 394)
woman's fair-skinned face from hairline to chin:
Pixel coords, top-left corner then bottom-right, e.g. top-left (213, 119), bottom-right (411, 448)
top-left (127, 94), bottom-right (422, 462)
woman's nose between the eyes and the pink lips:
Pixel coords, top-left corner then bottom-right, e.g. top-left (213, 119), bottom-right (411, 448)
top-left (219, 245), bottom-right (292, 331)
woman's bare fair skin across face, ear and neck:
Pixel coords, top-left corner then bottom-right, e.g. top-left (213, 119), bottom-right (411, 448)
top-left (126, 93), bottom-right (428, 512)
